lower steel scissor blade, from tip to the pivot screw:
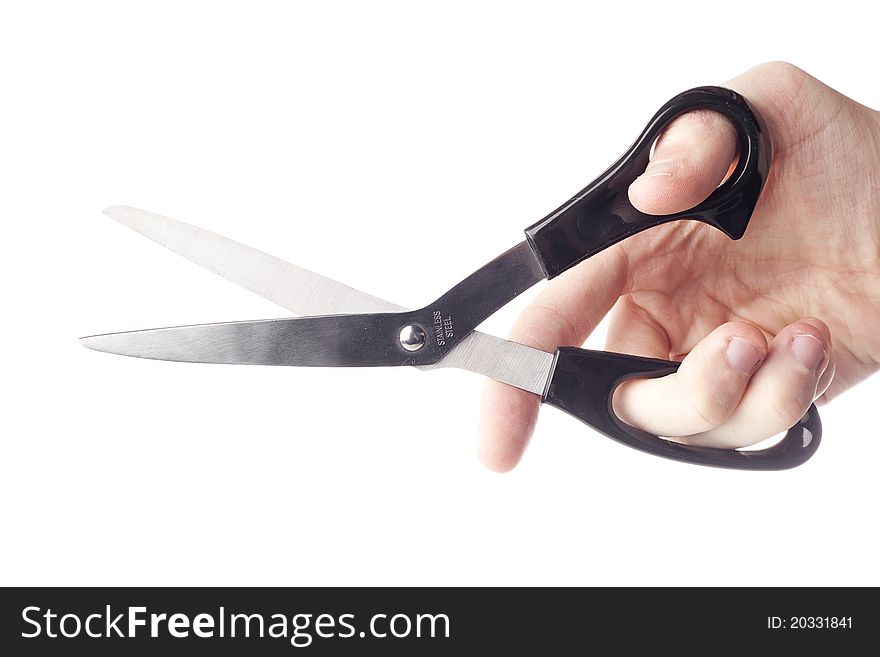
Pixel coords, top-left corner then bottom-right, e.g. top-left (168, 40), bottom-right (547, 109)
top-left (80, 315), bottom-right (407, 367)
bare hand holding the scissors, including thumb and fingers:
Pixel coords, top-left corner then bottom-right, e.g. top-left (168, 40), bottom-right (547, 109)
top-left (477, 62), bottom-right (880, 472)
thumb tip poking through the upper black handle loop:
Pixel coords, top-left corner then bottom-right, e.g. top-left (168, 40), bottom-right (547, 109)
top-left (629, 105), bottom-right (736, 214)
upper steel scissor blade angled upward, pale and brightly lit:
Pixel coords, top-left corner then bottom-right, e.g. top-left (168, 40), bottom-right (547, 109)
top-left (104, 205), bottom-right (405, 315)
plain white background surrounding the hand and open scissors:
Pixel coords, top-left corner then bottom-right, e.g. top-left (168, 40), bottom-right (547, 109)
top-left (0, 0), bottom-right (880, 585)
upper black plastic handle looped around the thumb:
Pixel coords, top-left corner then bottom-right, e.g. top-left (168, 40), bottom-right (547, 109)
top-left (526, 87), bottom-right (771, 278)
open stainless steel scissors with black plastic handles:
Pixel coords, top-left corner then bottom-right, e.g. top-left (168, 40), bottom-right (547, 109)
top-left (81, 87), bottom-right (822, 470)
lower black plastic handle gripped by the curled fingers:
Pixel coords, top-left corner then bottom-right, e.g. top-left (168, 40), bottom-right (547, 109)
top-left (543, 347), bottom-right (822, 470)
